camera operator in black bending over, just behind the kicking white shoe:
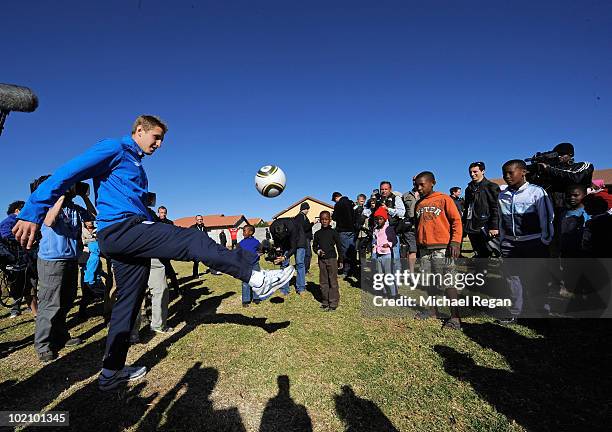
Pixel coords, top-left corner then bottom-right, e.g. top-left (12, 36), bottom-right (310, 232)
top-left (266, 217), bottom-right (306, 295)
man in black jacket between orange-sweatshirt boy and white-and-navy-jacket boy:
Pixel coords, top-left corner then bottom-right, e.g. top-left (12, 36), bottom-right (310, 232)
top-left (462, 162), bottom-right (500, 258)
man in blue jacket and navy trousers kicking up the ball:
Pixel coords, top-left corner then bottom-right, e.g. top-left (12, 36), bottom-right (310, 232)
top-left (13, 115), bottom-right (294, 390)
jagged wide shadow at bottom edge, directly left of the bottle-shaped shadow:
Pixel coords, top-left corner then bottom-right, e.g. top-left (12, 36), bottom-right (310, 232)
top-left (137, 362), bottom-right (246, 432)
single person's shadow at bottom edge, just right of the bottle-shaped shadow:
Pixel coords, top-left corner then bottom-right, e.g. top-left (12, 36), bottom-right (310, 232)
top-left (334, 385), bottom-right (399, 432)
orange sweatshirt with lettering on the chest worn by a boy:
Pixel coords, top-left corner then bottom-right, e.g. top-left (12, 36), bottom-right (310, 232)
top-left (415, 192), bottom-right (463, 249)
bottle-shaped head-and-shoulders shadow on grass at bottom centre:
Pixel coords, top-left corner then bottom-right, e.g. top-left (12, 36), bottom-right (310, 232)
top-left (259, 375), bottom-right (312, 432)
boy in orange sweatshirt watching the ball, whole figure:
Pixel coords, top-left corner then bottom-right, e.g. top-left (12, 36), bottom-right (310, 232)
top-left (414, 171), bottom-right (463, 330)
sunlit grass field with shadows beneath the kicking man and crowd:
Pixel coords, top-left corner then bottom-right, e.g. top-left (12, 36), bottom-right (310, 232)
top-left (0, 263), bottom-right (612, 432)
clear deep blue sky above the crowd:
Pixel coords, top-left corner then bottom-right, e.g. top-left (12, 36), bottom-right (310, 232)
top-left (0, 0), bottom-right (612, 219)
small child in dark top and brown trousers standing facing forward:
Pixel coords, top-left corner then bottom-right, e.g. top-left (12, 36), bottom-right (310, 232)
top-left (312, 211), bottom-right (342, 312)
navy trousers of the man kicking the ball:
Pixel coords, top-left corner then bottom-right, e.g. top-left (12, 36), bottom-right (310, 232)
top-left (98, 217), bottom-right (255, 370)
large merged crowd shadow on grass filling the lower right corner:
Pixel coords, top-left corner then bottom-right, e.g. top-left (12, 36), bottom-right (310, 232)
top-left (434, 320), bottom-right (612, 430)
